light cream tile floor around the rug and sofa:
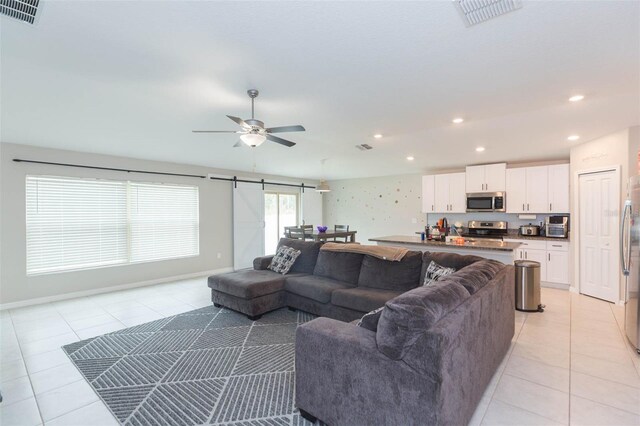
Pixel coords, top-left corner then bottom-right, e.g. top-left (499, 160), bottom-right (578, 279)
top-left (0, 279), bottom-right (640, 426)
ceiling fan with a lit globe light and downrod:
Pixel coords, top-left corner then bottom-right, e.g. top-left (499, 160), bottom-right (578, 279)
top-left (193, 89), bottom-right (305, 148)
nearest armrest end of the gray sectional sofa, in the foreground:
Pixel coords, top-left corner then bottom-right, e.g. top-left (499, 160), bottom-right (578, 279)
top-left (295, 318), bottom-right (437, 425)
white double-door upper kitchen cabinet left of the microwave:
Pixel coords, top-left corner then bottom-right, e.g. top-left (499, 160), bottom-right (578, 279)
top-left (422, 173), bottom-right (467, 213)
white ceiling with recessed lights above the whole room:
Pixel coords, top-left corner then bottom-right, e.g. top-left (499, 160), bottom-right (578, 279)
top-left (0, 1), bottom-right (640, 179)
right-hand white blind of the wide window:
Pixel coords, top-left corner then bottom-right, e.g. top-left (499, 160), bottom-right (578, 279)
top-left (129, 183), bottom-right (200, 262)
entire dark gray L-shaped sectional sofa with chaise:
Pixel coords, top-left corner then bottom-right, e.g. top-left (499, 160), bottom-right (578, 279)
top-left (209, 239), bottom-right (515, 426)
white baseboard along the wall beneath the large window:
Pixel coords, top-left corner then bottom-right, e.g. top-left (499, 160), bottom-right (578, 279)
top-left (0, 267), bottom-right (233, 311)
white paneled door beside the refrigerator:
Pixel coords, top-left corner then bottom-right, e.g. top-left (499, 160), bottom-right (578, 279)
top-left (579, 170), bottom-right (620, 302)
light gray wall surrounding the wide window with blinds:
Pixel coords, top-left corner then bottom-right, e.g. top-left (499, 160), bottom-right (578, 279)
top-left (0, 143), bottom-right (314, 305)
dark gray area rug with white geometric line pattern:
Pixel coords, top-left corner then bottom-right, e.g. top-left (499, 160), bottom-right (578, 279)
top-left (63, 306), bottom-right (314, 426)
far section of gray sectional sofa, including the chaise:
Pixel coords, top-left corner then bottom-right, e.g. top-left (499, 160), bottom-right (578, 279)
top-left (209, 238), bottom-right (428, 321)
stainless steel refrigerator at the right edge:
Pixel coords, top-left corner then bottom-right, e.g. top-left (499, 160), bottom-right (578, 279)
top-left (620, 176), bottom-right (640, 354)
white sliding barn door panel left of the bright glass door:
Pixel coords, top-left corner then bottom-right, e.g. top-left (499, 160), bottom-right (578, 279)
top-left (233, 182), bottom-right (264, 270)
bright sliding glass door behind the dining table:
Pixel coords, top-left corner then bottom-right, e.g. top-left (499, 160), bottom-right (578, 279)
top-left (264, 192), bottom-right (298, 255)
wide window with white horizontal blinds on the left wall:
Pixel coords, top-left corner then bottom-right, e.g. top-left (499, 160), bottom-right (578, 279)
top-left (26, 176), bottom-right (199, 275)
